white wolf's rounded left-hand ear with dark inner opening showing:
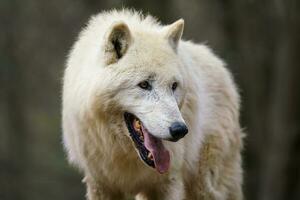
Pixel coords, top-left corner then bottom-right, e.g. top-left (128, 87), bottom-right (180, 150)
top-left (104, 21), bottom-right (131, 65)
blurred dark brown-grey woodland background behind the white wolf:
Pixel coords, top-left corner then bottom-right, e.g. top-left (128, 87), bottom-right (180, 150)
top-left (0, 0), bottom-right (300, 200)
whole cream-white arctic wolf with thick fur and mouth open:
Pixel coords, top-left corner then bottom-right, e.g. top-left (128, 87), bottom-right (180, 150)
top-left (63, 10), bottom-right (242, 200)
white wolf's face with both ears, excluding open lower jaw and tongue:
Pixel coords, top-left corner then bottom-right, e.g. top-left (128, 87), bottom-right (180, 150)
top-left (103, 20), bottom-right (187, 140)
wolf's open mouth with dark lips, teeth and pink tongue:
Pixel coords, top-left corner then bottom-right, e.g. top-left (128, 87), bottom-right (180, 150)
top-left (124, 112), bottom-right (170, 173)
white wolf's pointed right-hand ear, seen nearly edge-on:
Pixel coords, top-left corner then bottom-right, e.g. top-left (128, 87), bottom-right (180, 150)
top-left (165, 19), bottom-right (184, 51)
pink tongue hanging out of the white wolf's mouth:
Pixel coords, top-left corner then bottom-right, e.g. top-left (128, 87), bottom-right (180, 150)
top-left (142, 126), bottom-right (170, 174)
